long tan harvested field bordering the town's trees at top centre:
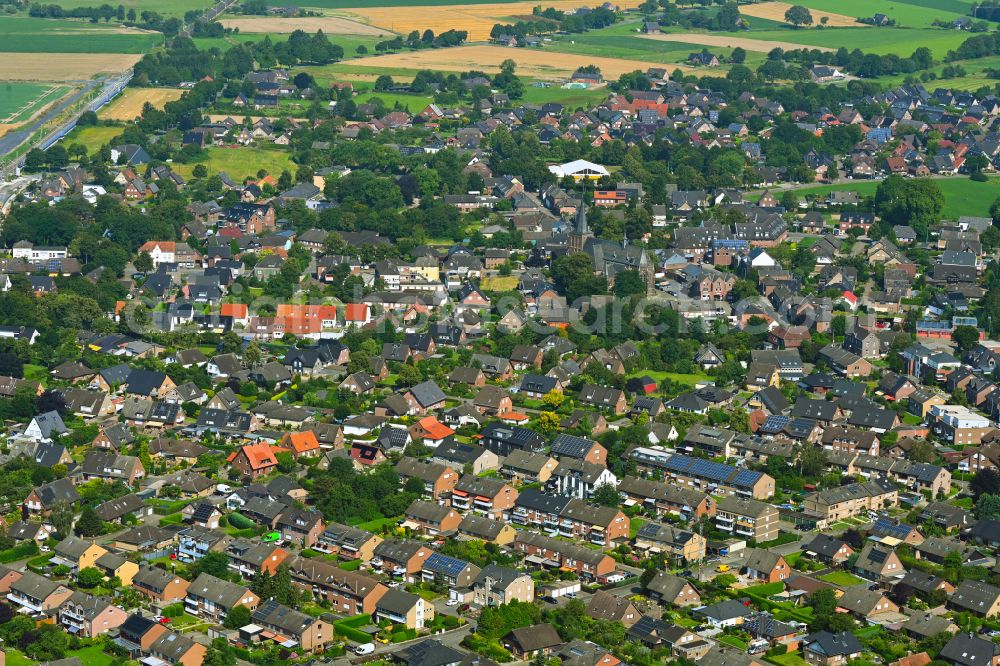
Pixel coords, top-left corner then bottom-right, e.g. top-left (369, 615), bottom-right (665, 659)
top-left (350, 46), bottom-right (708, 79)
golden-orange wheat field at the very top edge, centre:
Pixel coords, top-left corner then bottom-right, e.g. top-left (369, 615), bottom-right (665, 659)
top-left (343, 0), bottom-right (640, 42)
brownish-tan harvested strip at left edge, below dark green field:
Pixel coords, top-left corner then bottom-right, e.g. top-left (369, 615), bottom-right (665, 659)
top-left (0, 53), bottom-right (142, 81)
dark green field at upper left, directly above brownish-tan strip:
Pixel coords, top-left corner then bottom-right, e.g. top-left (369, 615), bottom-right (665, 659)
top-left (0, 16), bottom-right (163, 53)
